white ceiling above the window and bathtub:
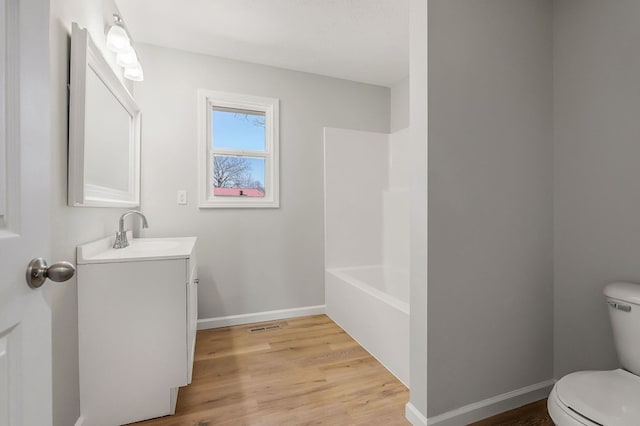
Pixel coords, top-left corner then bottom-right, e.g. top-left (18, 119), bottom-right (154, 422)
top-left (116, 0), bottom-right (409, 87)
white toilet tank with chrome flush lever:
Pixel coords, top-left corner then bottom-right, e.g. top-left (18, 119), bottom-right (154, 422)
top-left (604, 282), bottom-right (640, 375)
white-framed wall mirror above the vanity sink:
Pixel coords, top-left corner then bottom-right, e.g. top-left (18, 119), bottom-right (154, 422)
top-left (68, 23), bottom-right (140, 207)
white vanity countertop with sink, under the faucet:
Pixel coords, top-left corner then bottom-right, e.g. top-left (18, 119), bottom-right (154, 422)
top-left (76, 231), bottom-right (196, 265)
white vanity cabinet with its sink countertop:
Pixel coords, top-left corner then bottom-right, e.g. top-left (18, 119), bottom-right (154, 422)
top-left (77, 237), bottom-right (198, 426)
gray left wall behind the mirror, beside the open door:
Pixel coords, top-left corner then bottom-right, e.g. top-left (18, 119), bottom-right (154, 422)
top-left (45, 0), bottom-right (133, 426)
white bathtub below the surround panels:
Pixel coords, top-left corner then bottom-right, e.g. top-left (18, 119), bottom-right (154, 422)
top-left (325, 266), bottom-right (409, 387)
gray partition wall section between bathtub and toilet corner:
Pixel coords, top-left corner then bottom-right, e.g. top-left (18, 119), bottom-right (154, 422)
top-left (428, 0), bottom-right (553, 417)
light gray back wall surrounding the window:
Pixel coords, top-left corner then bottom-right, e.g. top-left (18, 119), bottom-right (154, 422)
top-left (135, 45), bottom-right (390, 318)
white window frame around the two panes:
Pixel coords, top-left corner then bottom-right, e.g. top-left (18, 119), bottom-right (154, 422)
top-left (198, 89), bottom-right (280, 208)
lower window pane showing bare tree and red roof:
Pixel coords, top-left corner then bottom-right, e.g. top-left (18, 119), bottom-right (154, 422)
top-left (213, 155), bottom-right (265, 197)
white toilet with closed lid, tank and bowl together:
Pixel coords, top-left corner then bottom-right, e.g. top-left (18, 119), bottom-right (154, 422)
top-left (547, 282), bottom-right (640, 426)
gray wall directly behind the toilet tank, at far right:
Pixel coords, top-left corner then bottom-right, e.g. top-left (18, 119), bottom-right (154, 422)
top-left (554, 0), bottom-right (640, 378)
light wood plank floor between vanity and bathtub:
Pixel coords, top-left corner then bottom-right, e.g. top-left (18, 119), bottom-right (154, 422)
top-left (131, 315), bottom-right (409, 426)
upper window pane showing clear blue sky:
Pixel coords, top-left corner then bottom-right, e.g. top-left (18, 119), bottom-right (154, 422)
top-left (211, 108), bottom-right (265, 151)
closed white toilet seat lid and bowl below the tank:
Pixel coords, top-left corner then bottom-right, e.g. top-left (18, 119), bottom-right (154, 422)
top-left (548, 369), bottom-right (640, 426)
